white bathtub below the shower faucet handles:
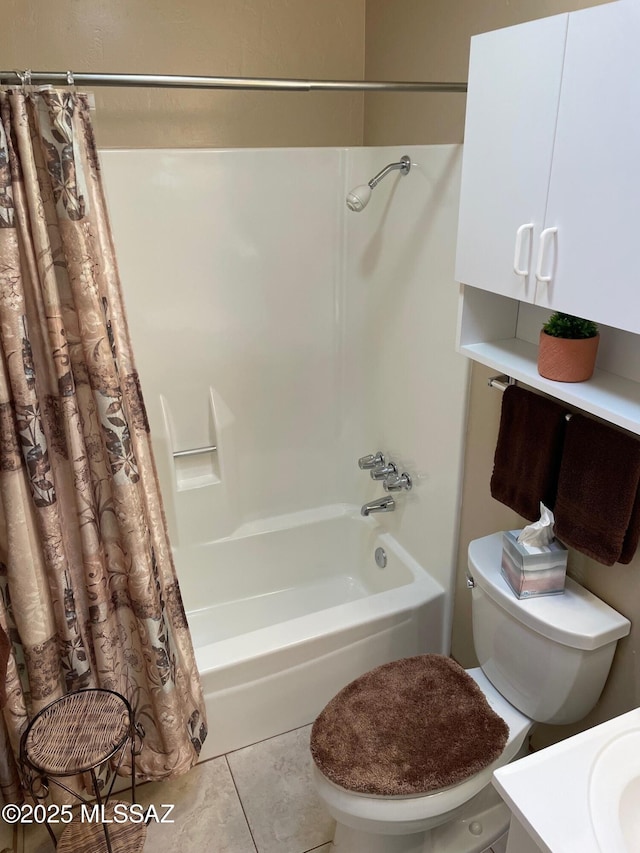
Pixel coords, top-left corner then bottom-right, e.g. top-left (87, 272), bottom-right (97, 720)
top-left (175, 505), bottom-right (446, 761)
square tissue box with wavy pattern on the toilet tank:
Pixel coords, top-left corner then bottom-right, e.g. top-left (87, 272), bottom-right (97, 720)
top-left (502, 530), bottom-right (567, 598)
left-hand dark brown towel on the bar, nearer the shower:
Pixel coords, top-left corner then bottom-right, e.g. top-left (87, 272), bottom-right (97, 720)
top-left (491, 385), bottom-right (567, 521)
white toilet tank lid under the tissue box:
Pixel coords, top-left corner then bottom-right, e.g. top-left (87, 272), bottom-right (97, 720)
top-left (469, 533), bottom-right (631, 650)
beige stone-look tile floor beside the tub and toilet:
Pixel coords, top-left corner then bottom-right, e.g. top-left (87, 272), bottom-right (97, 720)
top-left (15, 726), bottom-right (506, 853)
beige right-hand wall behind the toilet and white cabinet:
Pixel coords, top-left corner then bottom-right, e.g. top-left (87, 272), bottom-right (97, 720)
top-left (365, 0), bottom-right (640, 746)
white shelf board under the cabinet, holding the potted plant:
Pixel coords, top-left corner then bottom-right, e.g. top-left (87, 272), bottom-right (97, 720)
top-left (459, 338), bottom-right (640, 435)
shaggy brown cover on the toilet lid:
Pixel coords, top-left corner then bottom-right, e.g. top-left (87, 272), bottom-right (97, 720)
top-left (311, 655), bottom-right (509, 796)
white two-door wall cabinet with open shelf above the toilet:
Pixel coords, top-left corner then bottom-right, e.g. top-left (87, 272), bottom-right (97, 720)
top-left (456, 0), bottom-right (640, 434)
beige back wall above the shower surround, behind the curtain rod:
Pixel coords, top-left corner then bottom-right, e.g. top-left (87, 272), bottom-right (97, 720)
top-left (0, 0), bottom-right (365, 148)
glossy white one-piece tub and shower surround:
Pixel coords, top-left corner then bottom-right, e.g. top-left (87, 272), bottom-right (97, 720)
top-left (101, 146), bottom-right (467, 757)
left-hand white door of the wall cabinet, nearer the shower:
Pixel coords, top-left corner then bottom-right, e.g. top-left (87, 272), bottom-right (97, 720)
top-left (456, 15), bottom-right (568, 302)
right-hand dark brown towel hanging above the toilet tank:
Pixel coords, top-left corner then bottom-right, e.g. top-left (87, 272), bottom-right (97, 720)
top-left (555, 415), bottom-right (640, 566)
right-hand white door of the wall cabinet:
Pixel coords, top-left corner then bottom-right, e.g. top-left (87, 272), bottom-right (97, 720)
top-left (537, 0), bottom-right (640, 333)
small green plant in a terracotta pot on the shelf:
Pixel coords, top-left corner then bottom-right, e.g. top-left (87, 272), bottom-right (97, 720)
top-left (538, 311), bottom-right (600, 382)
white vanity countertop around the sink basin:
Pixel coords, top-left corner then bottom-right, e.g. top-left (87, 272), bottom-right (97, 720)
top-left (493, 708), bottom-right (640, 853)
